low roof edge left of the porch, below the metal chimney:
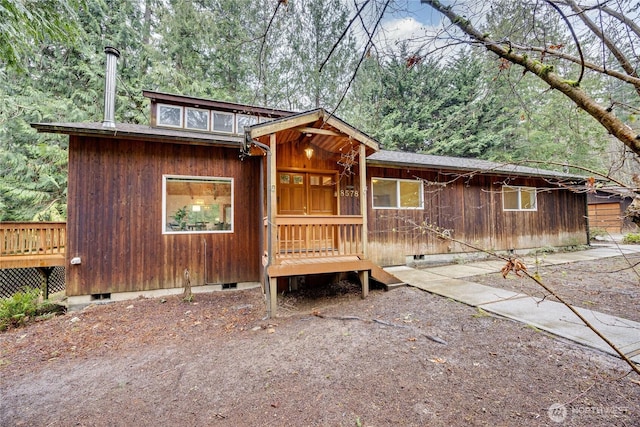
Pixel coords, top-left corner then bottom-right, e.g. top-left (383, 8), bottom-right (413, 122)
top-left (31, 123), bottom-right (244, 148)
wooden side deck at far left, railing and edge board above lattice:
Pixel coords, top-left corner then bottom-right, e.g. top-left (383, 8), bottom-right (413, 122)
top-left (0, 222), bottom-right (67, 268)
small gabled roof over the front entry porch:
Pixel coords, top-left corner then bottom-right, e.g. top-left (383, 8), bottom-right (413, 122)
top-left (247, 108), bottom-right (380, 154)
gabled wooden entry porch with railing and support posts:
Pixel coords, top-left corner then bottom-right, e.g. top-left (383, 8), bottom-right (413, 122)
top-left (244, 109), bottom-right (379, 316)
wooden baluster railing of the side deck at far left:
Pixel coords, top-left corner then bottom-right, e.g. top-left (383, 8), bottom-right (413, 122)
top-left (0, 222), bottom-right (67, 257)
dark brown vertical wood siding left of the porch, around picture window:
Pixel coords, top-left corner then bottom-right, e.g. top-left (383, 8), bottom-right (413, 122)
top-left (66, 136), bottom-right (261, 296)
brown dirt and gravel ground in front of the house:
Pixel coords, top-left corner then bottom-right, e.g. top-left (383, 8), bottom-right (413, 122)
top-left (0, 258), bottom-right (640, 426)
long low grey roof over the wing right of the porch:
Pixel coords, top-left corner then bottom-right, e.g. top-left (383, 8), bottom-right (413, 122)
top-left (367, 150), bottom-right (586, 181)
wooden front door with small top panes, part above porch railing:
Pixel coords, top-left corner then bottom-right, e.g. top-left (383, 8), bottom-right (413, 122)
top-left (278, 170), bottom-right (337, 215)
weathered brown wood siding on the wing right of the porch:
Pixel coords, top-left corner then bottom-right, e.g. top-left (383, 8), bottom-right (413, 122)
top-left (367, 167), bottom-right (588, 266)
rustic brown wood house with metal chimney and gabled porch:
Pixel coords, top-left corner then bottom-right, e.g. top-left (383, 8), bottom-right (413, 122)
top-left (33, 48), bottom-right (587, 315)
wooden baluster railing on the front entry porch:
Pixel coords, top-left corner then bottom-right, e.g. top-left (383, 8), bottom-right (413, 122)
top-left (275, 215), bottom-right (364, 262)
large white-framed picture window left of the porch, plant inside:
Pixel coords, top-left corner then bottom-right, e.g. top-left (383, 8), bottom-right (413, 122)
top-left (162, 175), bottom-right (233, 234)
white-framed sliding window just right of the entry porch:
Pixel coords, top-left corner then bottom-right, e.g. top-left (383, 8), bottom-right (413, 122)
top-left (371, 178), bottom-right (424, 209)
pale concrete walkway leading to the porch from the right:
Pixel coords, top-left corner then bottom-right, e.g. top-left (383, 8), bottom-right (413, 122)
top-left (385, 243), bottom-right (640, 363)
